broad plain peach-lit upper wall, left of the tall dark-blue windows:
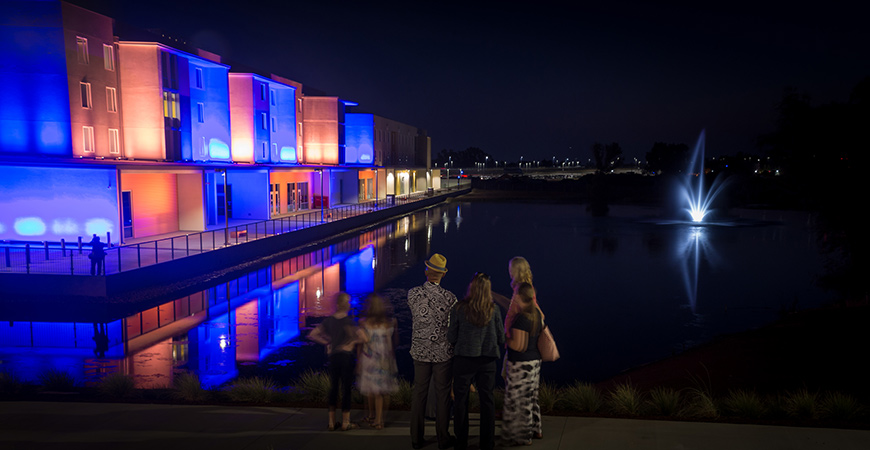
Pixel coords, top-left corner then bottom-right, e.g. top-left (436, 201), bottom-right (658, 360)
top-left (119, 42), bottom-right (166, 160)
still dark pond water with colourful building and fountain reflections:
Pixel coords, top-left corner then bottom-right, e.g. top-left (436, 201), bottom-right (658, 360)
top-left (0, 202), bottom-right (830, 387)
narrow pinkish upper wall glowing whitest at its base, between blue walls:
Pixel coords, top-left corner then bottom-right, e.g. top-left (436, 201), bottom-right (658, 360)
top-left (229, 73), bottom-right (254, 163)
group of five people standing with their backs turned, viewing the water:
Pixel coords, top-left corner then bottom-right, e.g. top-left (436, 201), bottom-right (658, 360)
top-left (309, 253), bottom-right (544, 450)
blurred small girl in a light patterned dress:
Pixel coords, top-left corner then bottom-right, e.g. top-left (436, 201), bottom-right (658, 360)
top-left (359, 294), bottom-right (399, 430)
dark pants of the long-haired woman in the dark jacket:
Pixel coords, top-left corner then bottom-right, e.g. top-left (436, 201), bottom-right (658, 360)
top-left (453, 356), bottom-right (498, 450)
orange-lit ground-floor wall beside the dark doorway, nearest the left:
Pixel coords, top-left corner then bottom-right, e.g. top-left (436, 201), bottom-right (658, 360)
top-left (121, 172), bottom-right (178, 238)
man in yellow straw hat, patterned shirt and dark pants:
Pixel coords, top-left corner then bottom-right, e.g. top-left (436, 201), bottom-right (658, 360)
top-left (408, 253), bottom-right (456, 449)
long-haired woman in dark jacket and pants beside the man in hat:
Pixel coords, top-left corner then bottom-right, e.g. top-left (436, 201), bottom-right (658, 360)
top-left (447, 273), bottom-right (505, 450)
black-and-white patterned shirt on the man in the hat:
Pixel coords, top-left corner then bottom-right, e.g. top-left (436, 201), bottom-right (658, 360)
top-left (408, 281), bottom-right (456, 363)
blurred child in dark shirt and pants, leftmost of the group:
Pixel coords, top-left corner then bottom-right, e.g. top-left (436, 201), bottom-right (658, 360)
top-left (308, 292), bottom-right (365, 431)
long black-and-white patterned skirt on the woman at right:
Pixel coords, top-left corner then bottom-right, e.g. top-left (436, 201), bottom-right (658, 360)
top-left (501, 359), bottom-right (542, 443)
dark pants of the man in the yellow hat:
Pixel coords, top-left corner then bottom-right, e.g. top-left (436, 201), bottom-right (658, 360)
top-left (411, 360), bottom-right (453, 447)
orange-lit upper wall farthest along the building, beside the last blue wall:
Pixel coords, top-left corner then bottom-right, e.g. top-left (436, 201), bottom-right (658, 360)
top-left (301, 97), bottom-right (344, 164)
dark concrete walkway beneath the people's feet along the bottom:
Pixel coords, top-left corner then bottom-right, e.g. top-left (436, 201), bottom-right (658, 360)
top-left (0, 402), bottom-right (870, 450)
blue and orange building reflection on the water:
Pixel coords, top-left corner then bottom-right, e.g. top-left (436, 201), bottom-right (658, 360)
top-left (0, 210), bottom-right (438, 388)
